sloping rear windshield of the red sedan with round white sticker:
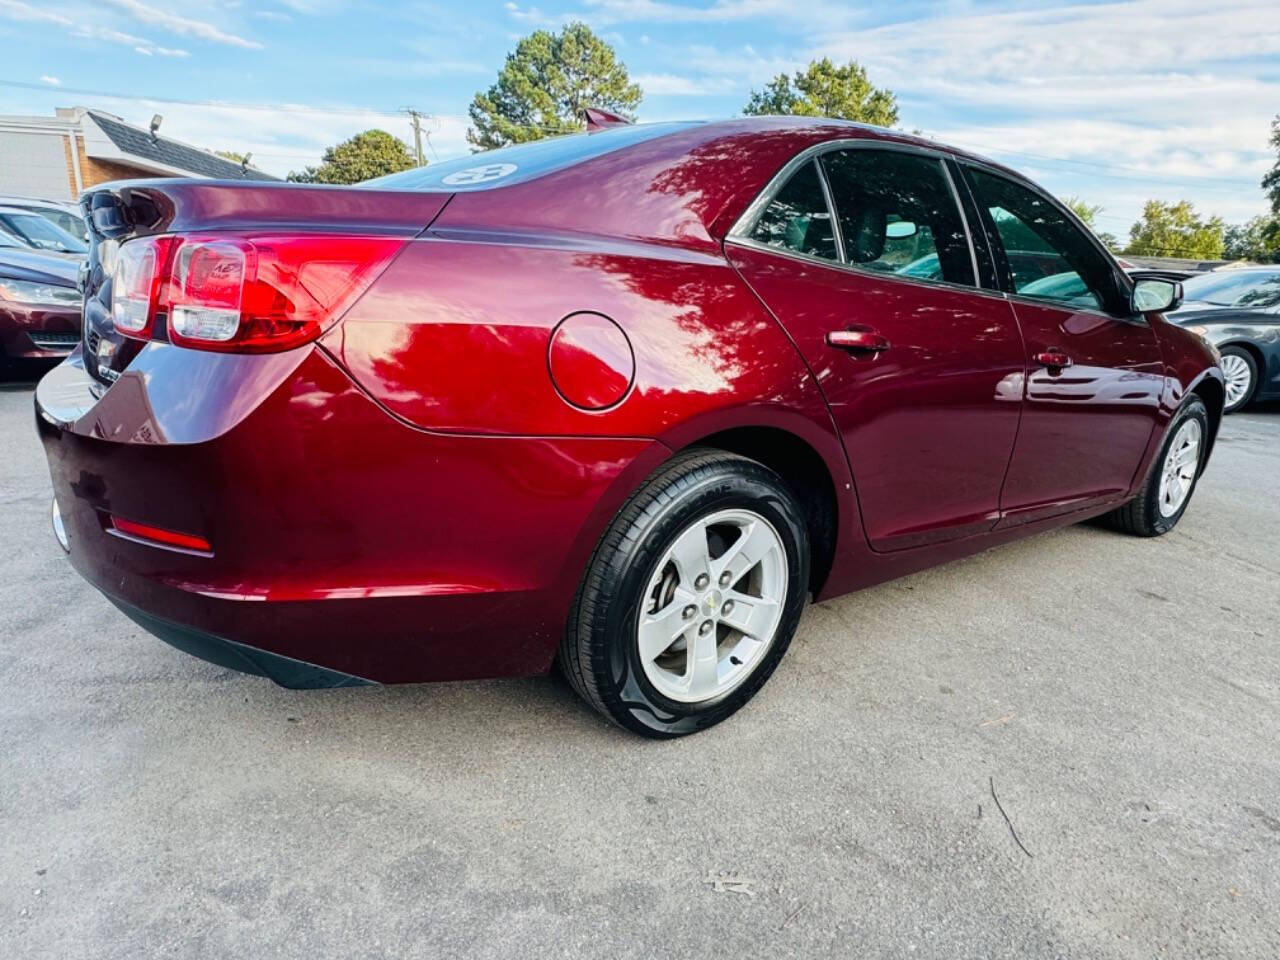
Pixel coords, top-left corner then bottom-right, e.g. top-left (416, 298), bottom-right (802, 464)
top-left (360, 122), bottom-right (694, 193)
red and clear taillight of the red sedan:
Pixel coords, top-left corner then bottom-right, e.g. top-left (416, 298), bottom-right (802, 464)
top-left (113, 234), bottom-right (406, 353)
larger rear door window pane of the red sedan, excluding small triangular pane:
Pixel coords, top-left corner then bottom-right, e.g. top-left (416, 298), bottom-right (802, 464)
top-left (822, 150), bottom-right (975, 287)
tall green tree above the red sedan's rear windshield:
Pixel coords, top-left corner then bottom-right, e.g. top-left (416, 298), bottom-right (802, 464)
top-left (467, 22), bottom-right (644, 150)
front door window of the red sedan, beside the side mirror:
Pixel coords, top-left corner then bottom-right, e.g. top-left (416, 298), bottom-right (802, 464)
top-left (968, 168), bottom-right (1120, 310)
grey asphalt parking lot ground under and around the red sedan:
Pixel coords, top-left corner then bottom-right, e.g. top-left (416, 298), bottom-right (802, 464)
top-left (0, 381), bottom-right (1280, 960)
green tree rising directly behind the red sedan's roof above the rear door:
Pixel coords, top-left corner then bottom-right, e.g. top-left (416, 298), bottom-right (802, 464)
top-left (742, 56), bottom-right (897, 127)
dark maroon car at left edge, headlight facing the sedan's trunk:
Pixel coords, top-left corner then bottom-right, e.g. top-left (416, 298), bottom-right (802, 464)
top-left (0, 236), bottom-right (81, 366)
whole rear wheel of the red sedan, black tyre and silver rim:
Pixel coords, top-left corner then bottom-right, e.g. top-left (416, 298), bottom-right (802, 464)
top-left (558, 451), bottom-right (809, 737)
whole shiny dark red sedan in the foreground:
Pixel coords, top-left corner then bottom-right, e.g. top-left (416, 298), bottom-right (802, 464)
top-left (36, 118), bottom-right (1224, 736)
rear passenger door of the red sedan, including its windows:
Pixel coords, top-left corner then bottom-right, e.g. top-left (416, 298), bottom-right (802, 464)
top-left (726, 141), bottom-right (1024, 550)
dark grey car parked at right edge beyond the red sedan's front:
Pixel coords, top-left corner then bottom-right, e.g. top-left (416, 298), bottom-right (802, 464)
top-left (1169, 266), bottom-right (1280, 413)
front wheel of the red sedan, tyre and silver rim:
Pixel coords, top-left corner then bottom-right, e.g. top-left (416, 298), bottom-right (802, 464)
top-left (1107, 397), bottom-right (1208, 536)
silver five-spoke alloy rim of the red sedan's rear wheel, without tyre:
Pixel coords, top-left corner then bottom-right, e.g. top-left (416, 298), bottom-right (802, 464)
top-left (636, 509), bottom-right (787, 703)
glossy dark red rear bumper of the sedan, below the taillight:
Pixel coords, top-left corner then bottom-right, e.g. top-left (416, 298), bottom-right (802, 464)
top-left (36, 343), bottom-right (667, 686)
